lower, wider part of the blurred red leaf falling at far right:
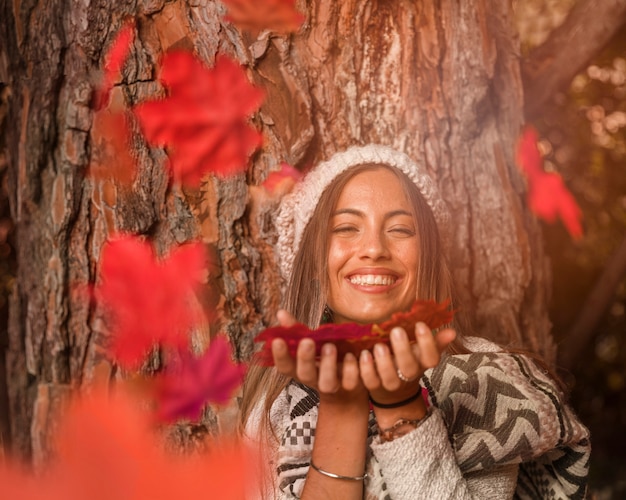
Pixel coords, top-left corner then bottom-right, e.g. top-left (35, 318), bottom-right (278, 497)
top-left (528, 173), bottom-right (583, 240)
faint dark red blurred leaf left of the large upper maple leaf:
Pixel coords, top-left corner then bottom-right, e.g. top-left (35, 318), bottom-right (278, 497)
top-left (89, 106), bottom-right (137, 186)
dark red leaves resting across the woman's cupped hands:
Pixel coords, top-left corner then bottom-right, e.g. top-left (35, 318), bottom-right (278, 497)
top-left (254, 300), bottom-right (454, 366)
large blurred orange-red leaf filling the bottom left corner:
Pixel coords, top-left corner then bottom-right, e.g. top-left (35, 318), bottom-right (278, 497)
top-left (0, 391), bottom-right (254, 500)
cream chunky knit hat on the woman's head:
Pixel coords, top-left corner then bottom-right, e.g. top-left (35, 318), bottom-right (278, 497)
top-left (276, 144), bottom-right (450, 282)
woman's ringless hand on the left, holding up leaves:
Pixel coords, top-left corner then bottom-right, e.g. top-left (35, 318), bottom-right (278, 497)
top-left (272, 310), bottom-right (367, 404)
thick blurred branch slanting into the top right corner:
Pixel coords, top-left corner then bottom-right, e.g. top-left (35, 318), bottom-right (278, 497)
top-left (522, 0), bottom-right (626, 121)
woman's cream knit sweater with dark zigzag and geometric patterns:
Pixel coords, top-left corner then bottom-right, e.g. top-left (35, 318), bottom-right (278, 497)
top-left (246, 339), bottom-right (590, 500)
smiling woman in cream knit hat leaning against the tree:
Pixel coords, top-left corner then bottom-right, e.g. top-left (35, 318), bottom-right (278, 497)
top-left (242, 145), bottom-right (589, 499)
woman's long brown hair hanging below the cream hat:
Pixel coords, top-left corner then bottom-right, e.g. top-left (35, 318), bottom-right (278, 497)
top-left (241, 164), bottom-right (468, 430)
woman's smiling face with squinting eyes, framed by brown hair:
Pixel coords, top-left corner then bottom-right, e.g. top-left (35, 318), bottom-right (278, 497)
top-left (327, 167), bottom-right (419, 323)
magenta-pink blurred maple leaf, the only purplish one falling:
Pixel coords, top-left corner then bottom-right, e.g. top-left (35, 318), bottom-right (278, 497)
top-left (156, 337), bottom-right (246, 421)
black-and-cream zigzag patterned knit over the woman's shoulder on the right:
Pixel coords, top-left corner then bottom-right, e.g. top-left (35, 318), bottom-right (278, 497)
top-left (423, 352), bottom-right (590, 499)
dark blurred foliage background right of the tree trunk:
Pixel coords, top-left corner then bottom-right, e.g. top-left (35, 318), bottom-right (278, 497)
top-left (515, 0), bottom-right (626, 498)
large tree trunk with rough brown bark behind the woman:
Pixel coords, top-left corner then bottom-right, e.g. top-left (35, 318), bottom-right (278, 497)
top-left (0, 0), bottom-right (555, 461)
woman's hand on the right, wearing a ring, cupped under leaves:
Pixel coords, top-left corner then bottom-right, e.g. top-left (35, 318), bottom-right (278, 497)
top-left (359, 322), bottom-right (456, 404)
